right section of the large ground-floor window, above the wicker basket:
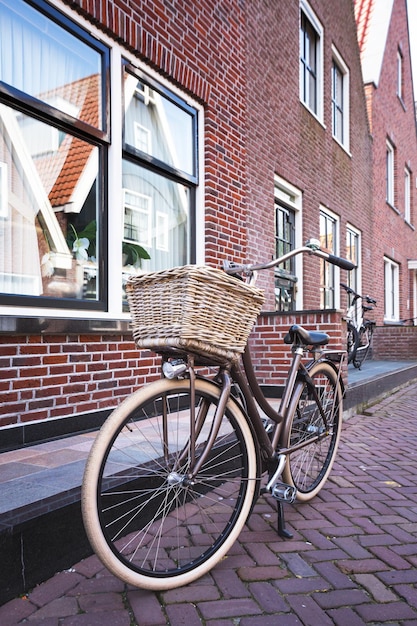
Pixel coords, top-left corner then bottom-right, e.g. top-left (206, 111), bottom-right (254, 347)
top-left (122, 67), bottom-right (197, 308)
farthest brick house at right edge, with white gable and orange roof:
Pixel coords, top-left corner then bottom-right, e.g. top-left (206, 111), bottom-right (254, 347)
top-left (355, 0), bottom-right (417, 359)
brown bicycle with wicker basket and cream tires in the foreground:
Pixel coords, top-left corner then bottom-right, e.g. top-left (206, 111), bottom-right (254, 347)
top-left (82, 242), bottom-right (354, 591)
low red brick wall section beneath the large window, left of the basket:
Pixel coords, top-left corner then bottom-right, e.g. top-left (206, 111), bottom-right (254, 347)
top-left (0, 333), bottom-right (159, 426)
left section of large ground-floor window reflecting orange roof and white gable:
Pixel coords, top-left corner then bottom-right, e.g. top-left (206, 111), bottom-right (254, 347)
top-left (0, 0), bottom-right (109, 308)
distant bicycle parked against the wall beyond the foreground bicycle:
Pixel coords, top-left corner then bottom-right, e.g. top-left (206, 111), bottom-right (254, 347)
top-left (340, 283), bottom-right (376, 369)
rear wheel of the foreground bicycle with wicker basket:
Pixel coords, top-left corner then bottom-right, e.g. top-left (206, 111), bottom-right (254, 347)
top-left (282, 361), bottom-right (343, 502)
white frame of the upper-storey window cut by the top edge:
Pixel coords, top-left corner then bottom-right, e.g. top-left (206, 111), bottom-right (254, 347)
top-left (299, 0), bottom-right (324, 124)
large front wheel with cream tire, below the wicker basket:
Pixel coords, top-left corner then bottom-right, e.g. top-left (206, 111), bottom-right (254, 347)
top-left (82, 379), bottom-right (260, 591)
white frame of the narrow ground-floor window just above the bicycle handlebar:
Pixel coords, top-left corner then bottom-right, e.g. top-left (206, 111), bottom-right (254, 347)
top-left (274, 174), bottom-right (304, 311)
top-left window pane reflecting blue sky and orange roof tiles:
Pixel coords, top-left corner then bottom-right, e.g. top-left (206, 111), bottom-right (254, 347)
top-left (0, 0), bottom-right (103, 128)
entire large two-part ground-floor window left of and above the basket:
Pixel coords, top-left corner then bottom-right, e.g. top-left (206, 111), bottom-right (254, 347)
top-left (0, 0), bottom-right (198, 315)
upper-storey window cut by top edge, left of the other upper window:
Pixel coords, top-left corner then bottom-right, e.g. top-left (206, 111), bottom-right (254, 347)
top-left (300, 0), bottom-right (323, 120)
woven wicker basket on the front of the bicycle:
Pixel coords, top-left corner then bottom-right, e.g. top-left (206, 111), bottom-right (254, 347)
top-left (126, 265), bottom-right (264, 362)
